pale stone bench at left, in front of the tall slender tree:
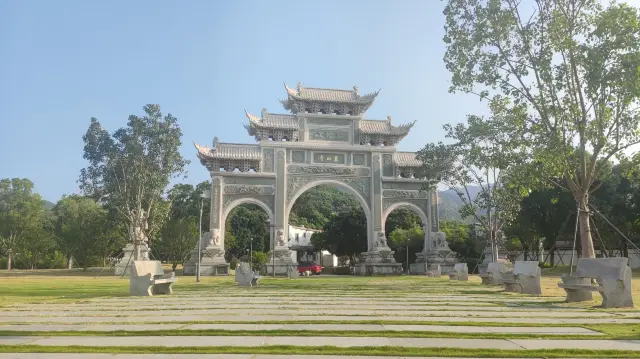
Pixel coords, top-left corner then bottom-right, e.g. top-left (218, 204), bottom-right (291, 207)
top-left (129, 261), bottom-right (177, 296)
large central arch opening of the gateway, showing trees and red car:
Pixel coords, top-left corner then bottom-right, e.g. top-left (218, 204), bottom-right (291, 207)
top-left (287, 181), bottom-right (370, 274)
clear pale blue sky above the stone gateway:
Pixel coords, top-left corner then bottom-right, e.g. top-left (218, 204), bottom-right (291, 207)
top-left (0, 0), bottom-right (492, 202)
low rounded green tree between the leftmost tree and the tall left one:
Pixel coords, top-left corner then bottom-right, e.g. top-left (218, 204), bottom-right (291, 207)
top-left (53, 195), bottom-right (108, 270)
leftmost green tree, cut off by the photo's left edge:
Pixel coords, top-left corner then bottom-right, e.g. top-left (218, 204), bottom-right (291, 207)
top-left (0, 178), bottom-right (46, 270)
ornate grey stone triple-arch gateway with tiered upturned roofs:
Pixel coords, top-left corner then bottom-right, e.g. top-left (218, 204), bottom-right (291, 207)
top-left (184, 84), bottom-right (455, 275)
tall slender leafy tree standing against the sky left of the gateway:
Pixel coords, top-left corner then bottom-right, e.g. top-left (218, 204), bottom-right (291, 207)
top-left (80, 105), bottom-right (188, 259)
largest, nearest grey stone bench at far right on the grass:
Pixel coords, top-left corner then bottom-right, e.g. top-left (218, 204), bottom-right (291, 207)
top-left (558, 257), bottom-right (633, 308)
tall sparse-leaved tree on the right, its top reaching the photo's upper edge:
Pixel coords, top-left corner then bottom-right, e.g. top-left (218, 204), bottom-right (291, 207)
top-left (444, 0), bottom-right (640, 257)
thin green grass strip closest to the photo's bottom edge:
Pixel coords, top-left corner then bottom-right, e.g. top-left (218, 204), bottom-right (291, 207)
top-left (0, 345), bottom-right (640, 359)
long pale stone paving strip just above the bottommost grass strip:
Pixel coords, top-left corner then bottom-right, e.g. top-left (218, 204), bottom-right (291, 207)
top-left (0, 336), bottom-right (640, 351)
